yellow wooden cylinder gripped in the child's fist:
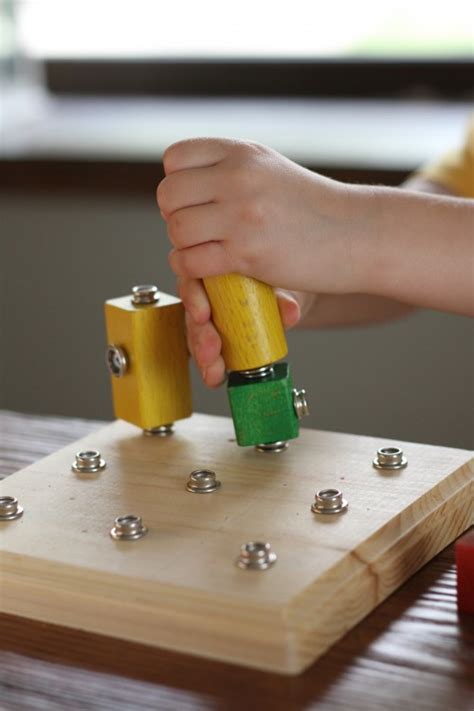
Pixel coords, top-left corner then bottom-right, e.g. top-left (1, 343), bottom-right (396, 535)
top-left (204, 274), bottom-right (288, 370)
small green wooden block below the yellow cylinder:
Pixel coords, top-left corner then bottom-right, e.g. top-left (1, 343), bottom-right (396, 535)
top-left (227, 363), bottom-right (299, 447)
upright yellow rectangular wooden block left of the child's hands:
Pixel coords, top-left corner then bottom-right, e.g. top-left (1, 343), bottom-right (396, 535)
top-left (105, 293), bottom-right (192, 429)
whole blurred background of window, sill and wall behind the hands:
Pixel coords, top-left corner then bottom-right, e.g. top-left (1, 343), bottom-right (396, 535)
top-left (0, 0), bottom-right (474, 448)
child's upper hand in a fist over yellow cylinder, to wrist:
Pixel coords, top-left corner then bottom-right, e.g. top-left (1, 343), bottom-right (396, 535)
top-left (157, 139), bottom-right (364, 293)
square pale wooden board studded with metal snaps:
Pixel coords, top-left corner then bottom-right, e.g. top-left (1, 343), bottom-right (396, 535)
top-left (0, 415), bottom-right (474, 674)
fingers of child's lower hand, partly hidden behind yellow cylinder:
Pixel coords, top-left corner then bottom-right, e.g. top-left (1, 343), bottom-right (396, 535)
top-left (178, 277), bottom-right (301, 388)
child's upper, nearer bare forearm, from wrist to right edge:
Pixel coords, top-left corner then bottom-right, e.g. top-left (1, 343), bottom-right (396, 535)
top-left (353, 187), bottom-right (474, 315)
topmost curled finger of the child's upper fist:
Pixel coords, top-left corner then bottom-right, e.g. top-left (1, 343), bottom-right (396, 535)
top-left (163, 138), bottom-right (235, 175)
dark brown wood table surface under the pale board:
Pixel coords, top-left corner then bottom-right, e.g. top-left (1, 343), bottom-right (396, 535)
top-left (0, 412), bottom-right (474, 711)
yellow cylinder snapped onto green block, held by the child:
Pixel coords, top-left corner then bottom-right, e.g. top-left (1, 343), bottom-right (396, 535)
top-left (204, 274), bottom-right (308, 444)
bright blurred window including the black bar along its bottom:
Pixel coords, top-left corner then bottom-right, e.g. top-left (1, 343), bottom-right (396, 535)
top-left (0, 0), bottom-right (474, 96)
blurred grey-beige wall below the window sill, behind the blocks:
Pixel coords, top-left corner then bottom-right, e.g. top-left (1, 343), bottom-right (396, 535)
top-left (0, 194), bottom-right (474, 447)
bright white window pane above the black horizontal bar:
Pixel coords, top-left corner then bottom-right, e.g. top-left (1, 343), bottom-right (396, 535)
top-left (14, 0), bottom-right (474, 59)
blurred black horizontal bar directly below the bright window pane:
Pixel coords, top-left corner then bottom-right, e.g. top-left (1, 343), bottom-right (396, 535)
top-left (45, 58), bottom-right (473, 98)
